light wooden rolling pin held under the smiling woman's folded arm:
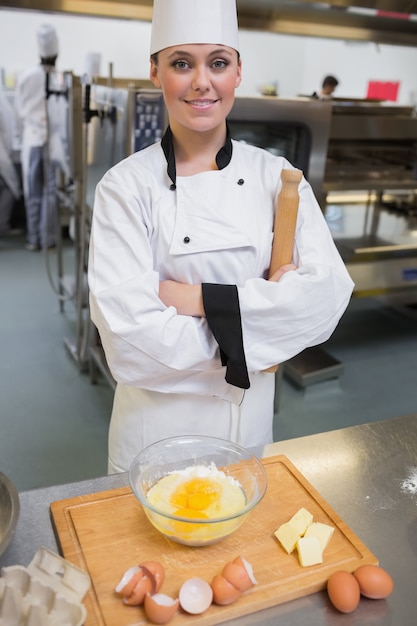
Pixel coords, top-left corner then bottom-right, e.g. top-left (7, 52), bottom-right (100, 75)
top-left (264, 170), bottom-right (303, 374)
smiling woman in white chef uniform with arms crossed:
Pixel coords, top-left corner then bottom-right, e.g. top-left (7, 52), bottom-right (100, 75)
top-left (89, 0), bottom-right (353, 472)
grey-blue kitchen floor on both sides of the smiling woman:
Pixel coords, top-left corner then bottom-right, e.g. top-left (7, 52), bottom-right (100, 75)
top-left (0, 232), bottom-right (417, 490)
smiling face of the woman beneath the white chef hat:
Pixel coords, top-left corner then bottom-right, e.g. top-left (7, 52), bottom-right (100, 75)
top-left (150, 44), bottom-right (241, 133)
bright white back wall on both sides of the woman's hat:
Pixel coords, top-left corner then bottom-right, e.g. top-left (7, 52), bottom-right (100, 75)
top-left (0, 6), bottom-right (417, 105)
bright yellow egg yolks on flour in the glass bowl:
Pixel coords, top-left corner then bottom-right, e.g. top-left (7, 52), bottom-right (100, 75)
top-left (170, 478), bottom-right (221, 519)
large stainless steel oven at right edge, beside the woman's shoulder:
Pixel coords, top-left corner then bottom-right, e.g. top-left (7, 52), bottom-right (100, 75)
top-left (323, 100), bottom-right (417, 301)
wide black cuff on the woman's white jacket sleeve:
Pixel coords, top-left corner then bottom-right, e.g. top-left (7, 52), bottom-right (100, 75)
top-left (201, 283), bottom-right (250, 389)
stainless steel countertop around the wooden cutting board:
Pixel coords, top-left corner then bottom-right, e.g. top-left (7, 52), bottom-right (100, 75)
top-left (0, 414), bottom-right (417, 626)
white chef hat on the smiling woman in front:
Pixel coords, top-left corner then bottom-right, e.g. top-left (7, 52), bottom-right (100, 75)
top-left (151, 0), bottom-right (239, 54)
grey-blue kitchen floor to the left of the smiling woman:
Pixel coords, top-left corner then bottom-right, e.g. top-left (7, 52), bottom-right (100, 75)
top-left (0, 232), bottom-right (112, 490)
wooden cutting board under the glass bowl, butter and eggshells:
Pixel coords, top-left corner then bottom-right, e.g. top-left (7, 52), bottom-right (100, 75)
top-left (51, 456), bottom-right (378, 626)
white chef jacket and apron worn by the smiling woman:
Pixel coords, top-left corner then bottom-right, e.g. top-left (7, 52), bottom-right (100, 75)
top-left (89, 134), bottom-right (353, 471)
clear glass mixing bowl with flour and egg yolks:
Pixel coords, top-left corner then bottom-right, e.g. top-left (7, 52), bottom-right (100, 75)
top-left (129, 436), bottom-right (268, 546)
